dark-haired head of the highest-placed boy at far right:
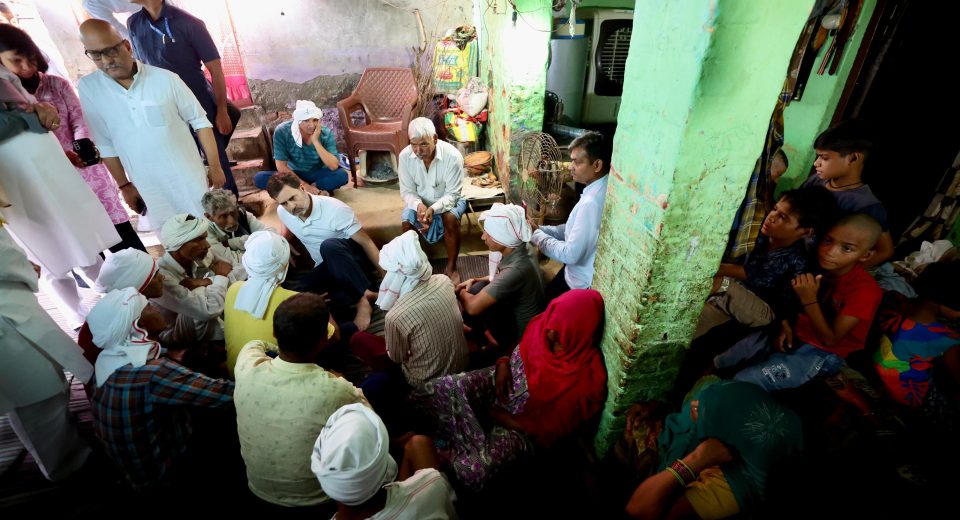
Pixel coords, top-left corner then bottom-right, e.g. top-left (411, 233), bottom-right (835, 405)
top-left (813, 119), bottom-right (873, 180)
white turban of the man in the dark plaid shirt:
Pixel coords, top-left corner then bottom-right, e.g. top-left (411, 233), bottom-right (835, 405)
top-left (87, 287), bottom-right (160, 386)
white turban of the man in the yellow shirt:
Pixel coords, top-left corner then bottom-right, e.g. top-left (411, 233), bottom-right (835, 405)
top-left (233, 231), bottom-right (290, 320)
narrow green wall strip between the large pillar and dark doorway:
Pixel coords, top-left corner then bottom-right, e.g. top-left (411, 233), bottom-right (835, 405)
top-left (777, 0), bottom-right (877, 191)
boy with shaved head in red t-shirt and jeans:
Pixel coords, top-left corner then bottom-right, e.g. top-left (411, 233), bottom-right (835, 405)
top-left (714, 213), bottom-right (883, 391)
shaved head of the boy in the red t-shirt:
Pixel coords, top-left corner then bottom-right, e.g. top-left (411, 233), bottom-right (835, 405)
top-left (817, 213), bottom-right (883, 276)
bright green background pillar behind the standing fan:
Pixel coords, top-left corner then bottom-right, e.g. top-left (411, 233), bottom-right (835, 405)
top-left (480, 0), bottom-right (552, 187)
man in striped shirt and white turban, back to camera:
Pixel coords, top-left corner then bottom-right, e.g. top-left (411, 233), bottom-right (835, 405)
top-left (350, 230), bottom-right (467, 386)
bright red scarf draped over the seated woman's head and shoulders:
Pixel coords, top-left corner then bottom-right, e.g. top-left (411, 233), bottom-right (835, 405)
top-left (515, 289), bottom-right (607, 446)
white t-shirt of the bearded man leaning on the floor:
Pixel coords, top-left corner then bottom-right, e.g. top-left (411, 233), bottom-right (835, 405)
top-left (277, 195), bottom-right (368, 266)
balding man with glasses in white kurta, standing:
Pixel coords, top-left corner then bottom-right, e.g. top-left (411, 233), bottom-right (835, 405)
top-left (78, 20), bottom-right (225, 230)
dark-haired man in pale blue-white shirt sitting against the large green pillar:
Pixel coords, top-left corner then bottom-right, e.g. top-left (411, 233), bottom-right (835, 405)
top-left (529, 132), bottom-right (611, 302)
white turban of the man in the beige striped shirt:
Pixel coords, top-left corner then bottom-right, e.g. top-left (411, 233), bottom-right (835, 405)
top-left (377, 229), bottom-right (433, 311)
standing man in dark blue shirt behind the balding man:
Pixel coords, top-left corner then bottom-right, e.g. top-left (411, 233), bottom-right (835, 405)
top-left (127, 0), bottom-right (240, 195)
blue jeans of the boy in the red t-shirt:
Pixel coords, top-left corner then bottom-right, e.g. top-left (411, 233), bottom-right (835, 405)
top-left (728, 341), bottom-right (843, 392)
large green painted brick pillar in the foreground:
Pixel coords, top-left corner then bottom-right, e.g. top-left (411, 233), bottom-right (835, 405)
top-left (594, 0), bottom-right (813, 454)
